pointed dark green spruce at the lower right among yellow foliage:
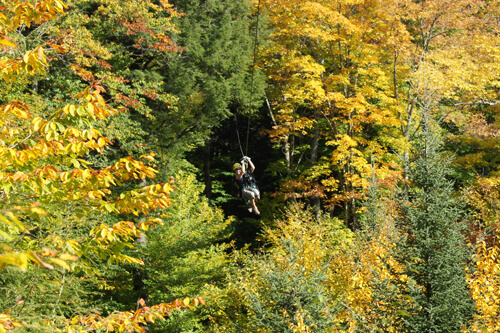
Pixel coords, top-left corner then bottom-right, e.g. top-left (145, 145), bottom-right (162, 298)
top-left (366, 114), bottom-right (474, 333)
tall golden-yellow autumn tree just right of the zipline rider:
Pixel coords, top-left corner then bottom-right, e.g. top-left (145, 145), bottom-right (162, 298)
top-left (261, 1), bottom-right (409, 228)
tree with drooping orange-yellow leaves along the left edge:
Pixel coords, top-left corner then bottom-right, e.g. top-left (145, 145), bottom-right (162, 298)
top-left (0, 0), bottom-right (200, 331)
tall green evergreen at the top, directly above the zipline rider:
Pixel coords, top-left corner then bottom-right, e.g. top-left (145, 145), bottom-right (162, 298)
top-left (163, 0), bottom-right (264, 138)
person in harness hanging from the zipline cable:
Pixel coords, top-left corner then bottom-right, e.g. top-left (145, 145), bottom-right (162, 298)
top-left (233, 156), bottom-right (260, 215)
